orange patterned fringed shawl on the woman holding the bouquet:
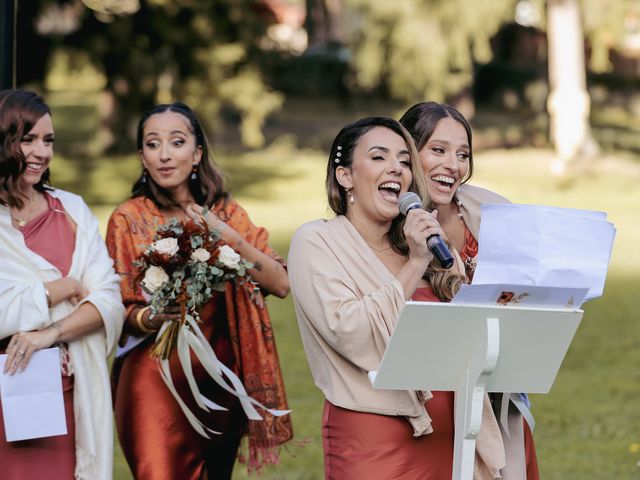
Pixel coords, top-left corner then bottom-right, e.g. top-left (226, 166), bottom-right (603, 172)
top-left (106, 197), bottom-right (293, 468)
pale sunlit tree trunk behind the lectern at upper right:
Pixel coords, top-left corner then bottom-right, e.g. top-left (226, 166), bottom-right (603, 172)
top-left (547, 0), bottom-right (598, 175)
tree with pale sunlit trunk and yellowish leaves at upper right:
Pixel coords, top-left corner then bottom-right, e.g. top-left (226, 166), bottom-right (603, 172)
top-left (537, 0), bottom-right (640, 174)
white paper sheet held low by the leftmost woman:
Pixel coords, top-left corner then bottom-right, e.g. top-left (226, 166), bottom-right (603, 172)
top-left (0, 348), bottom-right (67, 442)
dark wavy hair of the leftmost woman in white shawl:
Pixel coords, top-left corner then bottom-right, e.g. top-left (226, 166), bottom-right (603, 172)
top-left (0, 89), bottom-right (51, 209)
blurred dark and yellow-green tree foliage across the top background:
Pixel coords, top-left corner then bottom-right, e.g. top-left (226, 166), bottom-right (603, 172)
top-left (17, 0), bottom-right (640, 155)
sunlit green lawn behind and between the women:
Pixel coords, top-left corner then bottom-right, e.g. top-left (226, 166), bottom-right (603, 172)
top-left (76, 142), bottom-right (640, 480)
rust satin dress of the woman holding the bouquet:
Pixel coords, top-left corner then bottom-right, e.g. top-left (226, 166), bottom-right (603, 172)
top-left (114, 293), bottom-right (246, 480)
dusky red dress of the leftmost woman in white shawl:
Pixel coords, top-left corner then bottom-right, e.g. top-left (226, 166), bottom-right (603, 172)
top-left (0, 194), bottom-right (76, 480)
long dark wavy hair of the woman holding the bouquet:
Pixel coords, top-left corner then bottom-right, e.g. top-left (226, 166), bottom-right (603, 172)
top-left (132, 102), bottom-right (229, 208)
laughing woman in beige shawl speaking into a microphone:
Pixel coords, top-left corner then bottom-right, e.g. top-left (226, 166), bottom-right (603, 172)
top-left (288, 117), bottom-right (504, 480)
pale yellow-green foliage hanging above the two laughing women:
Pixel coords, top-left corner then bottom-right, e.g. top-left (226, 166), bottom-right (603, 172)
top-left (346, 0), bottom-right (516, 102)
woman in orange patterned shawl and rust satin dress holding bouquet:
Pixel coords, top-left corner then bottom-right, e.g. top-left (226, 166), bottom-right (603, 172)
top-left (107, 103), bottom-right (292, 480)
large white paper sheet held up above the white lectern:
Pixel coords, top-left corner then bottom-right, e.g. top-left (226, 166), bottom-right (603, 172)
top-left (473, 204), bottom-right (615, 300)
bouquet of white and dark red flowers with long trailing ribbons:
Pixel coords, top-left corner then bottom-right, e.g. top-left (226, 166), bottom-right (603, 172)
top-left (136, 216), bottom-right (289, 438)
